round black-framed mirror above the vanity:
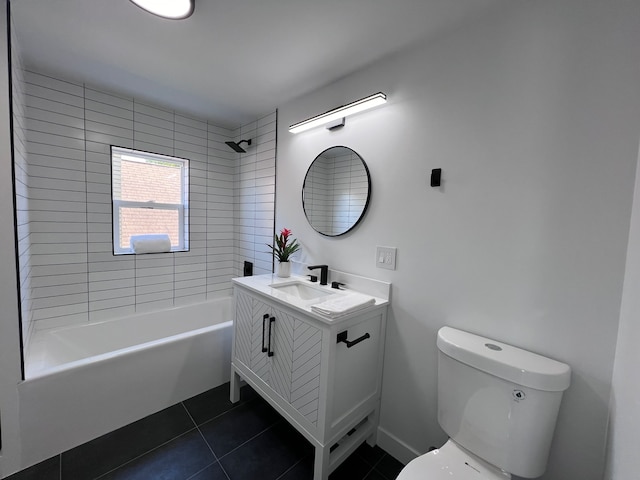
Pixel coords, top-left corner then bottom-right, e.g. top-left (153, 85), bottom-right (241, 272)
top-left (302, 147), bottom-right (371, 237)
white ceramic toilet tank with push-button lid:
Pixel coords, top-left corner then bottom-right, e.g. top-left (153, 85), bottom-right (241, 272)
top-left (437, 327), bottom-right (571, 478)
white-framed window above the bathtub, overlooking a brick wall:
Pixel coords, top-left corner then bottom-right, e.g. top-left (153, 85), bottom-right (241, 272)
top-left (111, 146), bottom-right (189, 255)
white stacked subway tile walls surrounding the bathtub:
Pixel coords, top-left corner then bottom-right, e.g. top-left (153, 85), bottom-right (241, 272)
top-left (15, 66), bottom-right (276, 338)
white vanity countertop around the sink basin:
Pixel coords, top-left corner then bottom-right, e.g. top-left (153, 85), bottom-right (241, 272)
top-left (233, 274), bottom-right (389, 324)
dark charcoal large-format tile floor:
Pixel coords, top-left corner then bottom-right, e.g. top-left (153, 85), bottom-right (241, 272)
top-left (8, 384), bottom-right (402, 480)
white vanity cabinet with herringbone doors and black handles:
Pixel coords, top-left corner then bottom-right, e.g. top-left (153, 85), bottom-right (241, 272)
top-left (231, 276), bottom-right (387, 480)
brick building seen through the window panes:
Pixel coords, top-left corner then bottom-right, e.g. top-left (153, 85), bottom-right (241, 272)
top-left (120, 159), bottom-right (182, 249)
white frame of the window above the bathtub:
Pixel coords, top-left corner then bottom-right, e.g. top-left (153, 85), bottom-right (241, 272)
top-left (110, 145), bottom-right (190, 255)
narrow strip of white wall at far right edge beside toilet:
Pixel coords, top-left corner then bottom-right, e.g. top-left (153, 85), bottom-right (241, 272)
top-left (605, 140), bottom-right (640, 480)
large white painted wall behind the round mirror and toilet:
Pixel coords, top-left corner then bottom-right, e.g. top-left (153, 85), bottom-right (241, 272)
top-left (276, 0), bottom-right (640, 480)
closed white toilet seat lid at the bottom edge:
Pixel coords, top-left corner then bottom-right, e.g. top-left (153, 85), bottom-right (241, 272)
top-left (396, 440), bottom-right (511, 480)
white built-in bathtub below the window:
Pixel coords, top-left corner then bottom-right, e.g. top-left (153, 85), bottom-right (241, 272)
top-left (18, 297), bottom-right (232, 465)
